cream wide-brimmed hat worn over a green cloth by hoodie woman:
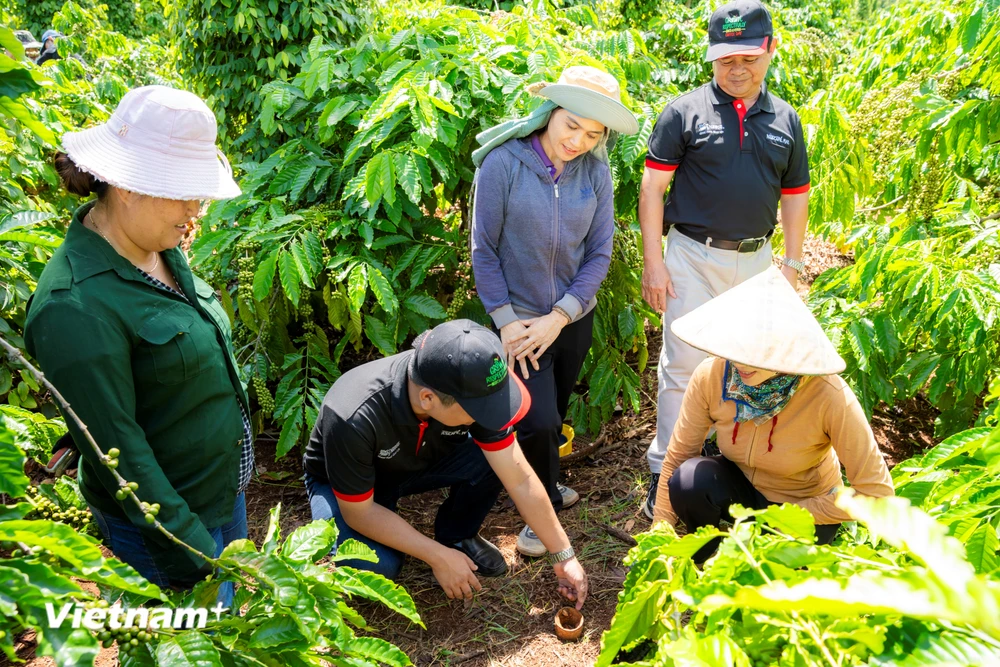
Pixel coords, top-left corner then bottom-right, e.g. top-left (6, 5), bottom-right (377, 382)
top-left (528, 65), bottom-right (639, 134)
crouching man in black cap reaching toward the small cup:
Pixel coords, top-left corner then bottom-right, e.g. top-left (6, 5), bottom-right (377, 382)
top-left (304, 320), bottom-right (587, 608)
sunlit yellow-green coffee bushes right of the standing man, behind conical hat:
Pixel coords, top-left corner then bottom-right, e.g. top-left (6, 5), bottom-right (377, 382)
top-left (803, 3), bottom-right (1000, 435)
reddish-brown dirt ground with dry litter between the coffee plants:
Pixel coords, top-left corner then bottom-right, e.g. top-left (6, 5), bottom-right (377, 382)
top-left (7, 238), bottom-right (936, 667)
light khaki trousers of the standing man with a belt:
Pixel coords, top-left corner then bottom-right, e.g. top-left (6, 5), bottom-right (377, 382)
top-left (646, 227), bottom-right (771, 473)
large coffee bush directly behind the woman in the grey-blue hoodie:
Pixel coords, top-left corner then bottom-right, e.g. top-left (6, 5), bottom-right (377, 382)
top-left (191, 3), bottom-right (672, 448)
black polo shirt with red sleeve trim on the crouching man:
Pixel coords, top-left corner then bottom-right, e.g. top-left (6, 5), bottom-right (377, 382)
top-left (303, 350), bottom-right (531, 502)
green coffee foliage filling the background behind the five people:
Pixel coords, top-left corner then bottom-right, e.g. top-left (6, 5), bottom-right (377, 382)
top-left (0, 0), bottom-right (1000, 446)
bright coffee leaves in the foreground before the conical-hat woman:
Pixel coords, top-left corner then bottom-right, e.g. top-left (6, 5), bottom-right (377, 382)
top-left (596, 429), bottom-right (1000, 667)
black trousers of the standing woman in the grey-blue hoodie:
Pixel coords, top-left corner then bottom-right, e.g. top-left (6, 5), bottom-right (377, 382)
top-left (511, 311), bottom-right (594, 512)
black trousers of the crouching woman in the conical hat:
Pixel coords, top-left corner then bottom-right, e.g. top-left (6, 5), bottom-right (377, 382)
top-left (667, 456), bottom-right (840, 563)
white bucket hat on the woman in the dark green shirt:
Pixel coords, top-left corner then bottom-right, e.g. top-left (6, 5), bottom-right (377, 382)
top-left (63, 86), bottom-right (240, 201)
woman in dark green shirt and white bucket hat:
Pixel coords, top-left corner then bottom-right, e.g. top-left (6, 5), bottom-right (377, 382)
top-left (25, 86), bottom-right (253, 605)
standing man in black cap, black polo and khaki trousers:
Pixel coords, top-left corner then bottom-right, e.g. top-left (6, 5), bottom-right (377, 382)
top-left (639, 0), bottom-right (809, 518)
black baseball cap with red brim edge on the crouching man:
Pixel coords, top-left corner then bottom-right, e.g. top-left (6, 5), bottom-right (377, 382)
top-left (410, 320), bottom-right (531, 431)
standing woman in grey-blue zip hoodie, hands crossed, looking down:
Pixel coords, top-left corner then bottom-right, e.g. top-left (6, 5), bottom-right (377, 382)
top-left (472, 66), bottom-right (639, 556)
